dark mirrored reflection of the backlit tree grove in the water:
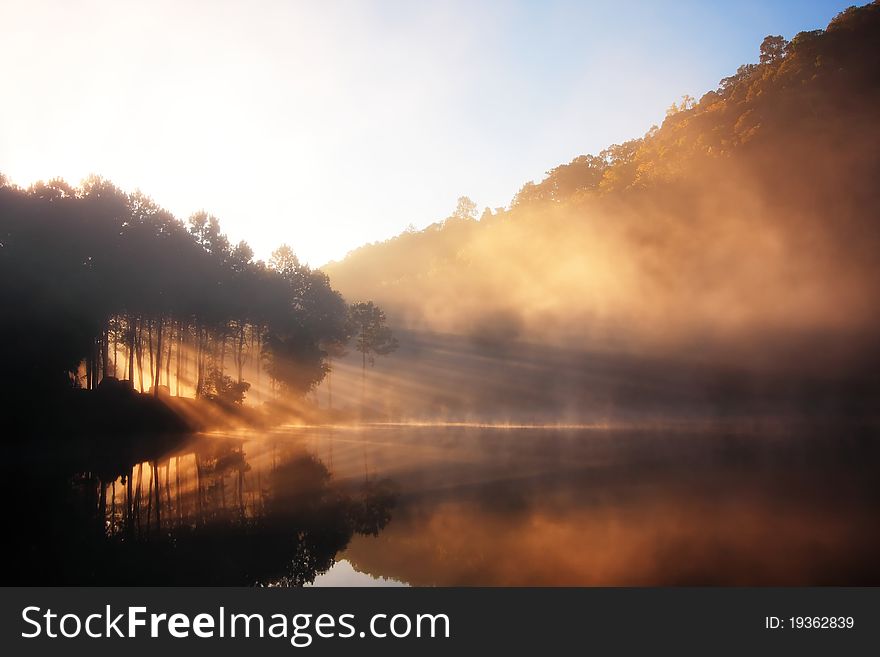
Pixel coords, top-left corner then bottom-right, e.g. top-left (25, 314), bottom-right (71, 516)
top-left (5, 438), bottom-right (396, 586)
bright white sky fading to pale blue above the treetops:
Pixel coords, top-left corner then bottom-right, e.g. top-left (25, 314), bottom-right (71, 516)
top-left (0, 0), bottom-right (852, 266)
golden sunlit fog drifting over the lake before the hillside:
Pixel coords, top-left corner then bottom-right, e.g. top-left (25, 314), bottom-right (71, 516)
top-left (325, 116), bottom-right (880, 420)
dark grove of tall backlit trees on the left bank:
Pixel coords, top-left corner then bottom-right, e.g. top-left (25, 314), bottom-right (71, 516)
top-left (0, 176), bottom-right (347, 403)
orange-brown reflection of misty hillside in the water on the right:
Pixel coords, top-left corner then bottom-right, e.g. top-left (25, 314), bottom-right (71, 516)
top-left (306, 425), bottom-right (880, 586)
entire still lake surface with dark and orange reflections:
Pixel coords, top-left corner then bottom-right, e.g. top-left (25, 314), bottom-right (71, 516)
top-left (5, 426), bottom-right (880, 586)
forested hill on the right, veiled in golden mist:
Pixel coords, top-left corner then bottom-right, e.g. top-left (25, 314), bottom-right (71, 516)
top-left (324, 2), bottom-right (880, 364)
